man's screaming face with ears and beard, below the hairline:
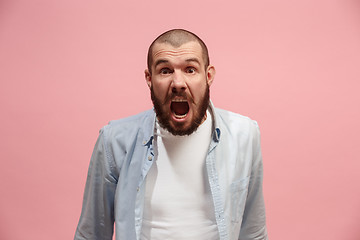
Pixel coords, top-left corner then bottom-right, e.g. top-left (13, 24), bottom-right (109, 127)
top-left (145, 41), bottom-right (215, 135)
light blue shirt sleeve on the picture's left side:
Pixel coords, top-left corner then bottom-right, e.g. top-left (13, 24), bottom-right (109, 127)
top-left (74, 129), bottom-right (117, 240)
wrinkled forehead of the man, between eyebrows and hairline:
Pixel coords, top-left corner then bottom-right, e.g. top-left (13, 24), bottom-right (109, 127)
top-left (152, 41), bottom-right (203, 64)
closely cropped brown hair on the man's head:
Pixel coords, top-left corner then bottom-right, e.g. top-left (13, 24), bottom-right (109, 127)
top-left (147, 29), bottom-right (210, 74)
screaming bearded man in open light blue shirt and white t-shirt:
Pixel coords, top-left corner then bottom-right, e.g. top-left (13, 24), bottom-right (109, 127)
top-left (75, 29), bottom-right (267, 240)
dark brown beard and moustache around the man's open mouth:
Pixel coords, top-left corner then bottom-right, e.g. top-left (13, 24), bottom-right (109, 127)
top-left (150, 84), bottom-right (210, 136)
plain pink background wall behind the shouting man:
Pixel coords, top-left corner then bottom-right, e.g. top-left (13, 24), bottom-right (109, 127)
top-left (0, 0), bottom-right (360, 240)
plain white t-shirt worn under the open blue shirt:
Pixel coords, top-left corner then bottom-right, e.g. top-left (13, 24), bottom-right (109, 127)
top-left (141, 112), bottom-right (219, 240)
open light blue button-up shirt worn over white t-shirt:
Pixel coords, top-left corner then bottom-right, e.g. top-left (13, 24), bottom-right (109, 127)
top-left (74, 104), bottom-right (268, 240)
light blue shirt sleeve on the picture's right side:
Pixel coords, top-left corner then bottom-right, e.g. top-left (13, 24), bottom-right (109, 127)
top-left (239, 121), bottom-right (268, 240)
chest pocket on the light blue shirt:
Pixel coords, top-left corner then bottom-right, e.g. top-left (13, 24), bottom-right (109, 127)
top-left (230, 177), bottom-right (250, 222)
